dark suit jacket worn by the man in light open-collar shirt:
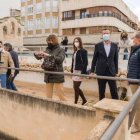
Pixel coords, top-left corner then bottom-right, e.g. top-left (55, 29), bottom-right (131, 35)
top-left (91, 42), bottom-right (118, 76)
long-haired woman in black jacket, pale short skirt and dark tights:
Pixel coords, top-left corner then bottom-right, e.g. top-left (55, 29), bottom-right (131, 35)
top-left (71, 37), bottom-right (88, 105)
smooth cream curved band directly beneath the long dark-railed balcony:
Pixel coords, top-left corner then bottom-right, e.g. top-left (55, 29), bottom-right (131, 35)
top-left (61, 17), bottom-right (135, 32)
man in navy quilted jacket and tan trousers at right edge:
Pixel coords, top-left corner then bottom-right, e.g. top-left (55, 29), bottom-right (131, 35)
top-left (128, 32), bottom-right (140, 133)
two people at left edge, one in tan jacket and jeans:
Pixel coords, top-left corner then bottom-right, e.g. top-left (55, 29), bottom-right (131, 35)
top-left (0, 41), bottom-right (19, 91)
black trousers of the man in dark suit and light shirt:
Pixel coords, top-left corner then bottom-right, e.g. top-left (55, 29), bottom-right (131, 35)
top-left (98, 68), bottom-right (119, 100)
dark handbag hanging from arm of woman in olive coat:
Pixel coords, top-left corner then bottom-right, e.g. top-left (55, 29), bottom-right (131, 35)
top-left (41, 57), bottom-right (57, 71)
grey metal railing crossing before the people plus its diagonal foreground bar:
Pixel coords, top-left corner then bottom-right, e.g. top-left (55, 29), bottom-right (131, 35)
top-left (0, 66), bottom-right (140, 140)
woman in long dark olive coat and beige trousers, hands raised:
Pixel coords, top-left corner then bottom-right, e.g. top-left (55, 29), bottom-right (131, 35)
top-left (34, 35), bottom-right (66, 101)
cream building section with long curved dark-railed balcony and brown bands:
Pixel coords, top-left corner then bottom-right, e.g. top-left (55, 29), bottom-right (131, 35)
top-left (59, 0), bottom-right (138, 36)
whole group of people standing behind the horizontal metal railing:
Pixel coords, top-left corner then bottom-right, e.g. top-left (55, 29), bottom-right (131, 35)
top-left (0, 29), bottom-right (140, 132)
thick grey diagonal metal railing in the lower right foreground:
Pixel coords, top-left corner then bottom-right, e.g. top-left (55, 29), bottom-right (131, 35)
top-left (101, 88), bottom-right (140, 140)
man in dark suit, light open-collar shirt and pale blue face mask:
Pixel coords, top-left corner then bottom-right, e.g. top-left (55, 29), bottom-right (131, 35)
top-left (91, 29), bottom-right (118, 100)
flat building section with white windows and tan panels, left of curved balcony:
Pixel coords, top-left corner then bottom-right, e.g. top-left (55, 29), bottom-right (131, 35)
top-left (21, 0), bottom-right (58, 38)
